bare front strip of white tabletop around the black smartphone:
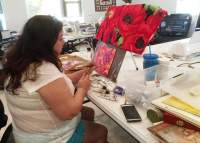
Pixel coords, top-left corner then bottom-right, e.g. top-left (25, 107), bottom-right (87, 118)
top-left (89, 91), bottom-right (158, 143)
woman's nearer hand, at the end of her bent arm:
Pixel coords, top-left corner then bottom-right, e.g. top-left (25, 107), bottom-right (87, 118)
top-left (78, 74), bottom-right (91, 91)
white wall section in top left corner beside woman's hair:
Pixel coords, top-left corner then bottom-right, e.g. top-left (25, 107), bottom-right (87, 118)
top-left (2, 0), bottom-right (27, 31)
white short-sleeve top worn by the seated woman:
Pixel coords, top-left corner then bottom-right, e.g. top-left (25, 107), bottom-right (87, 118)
top-left (5, 62), bottom-right (80, 143)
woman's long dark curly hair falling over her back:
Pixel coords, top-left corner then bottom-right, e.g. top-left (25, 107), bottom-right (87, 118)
top-left (3, 15), bottom-right (63, 94)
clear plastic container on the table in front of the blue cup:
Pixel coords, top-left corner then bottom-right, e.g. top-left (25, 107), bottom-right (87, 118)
top-left (123, 64), bottom-right (172, 108)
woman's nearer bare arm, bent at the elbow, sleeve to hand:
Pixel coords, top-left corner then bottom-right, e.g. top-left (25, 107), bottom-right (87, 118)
top-left (38, 75), bottom-right (90, 120)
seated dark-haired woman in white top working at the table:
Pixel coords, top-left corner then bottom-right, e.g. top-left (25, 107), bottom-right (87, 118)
top-left (4, 15), bottom-right (107, 143)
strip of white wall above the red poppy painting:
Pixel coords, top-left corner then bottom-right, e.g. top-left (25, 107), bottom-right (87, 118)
top-left (133, 0), bottom-right (177, 14)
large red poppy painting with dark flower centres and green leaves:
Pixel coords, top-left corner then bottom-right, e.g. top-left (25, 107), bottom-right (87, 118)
top-left (96, 4), bottom-right (167, 54)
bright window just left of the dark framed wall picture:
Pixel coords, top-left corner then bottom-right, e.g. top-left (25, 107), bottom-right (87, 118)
top-left (63, 0), bottom-right (82, 17)
